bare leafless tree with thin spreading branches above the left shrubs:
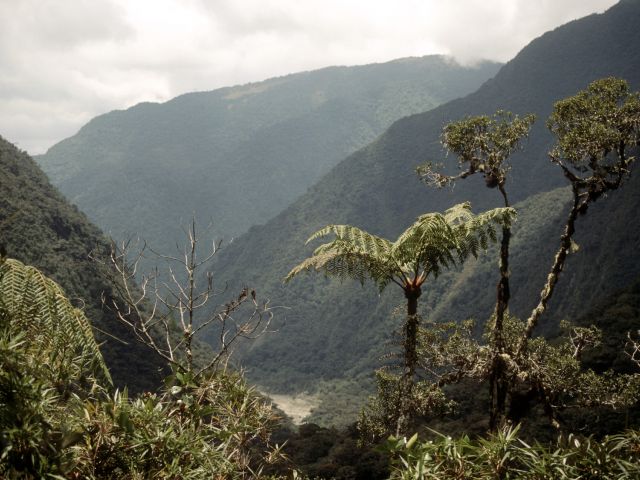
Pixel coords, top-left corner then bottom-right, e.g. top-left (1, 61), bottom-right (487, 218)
top-left (103, 219), bottom-right (273, 379)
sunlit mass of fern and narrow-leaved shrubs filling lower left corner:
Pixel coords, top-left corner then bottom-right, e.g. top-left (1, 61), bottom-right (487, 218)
top-left (0, 259), bottom-right (279, 479)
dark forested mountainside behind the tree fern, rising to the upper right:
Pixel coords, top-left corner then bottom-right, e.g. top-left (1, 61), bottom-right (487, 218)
top-left (209, 0), bottom-right (640, 418)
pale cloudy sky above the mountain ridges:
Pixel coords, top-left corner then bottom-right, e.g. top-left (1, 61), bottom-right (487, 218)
top-left (0, 0), bottom-right (616, 154)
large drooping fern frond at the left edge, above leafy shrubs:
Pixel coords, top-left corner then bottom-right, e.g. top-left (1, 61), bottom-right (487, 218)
top-left (0, 259), bottom-right (111, 383)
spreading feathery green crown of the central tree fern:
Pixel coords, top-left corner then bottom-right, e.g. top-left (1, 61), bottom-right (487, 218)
top-left (285, 202), bottom-right (515, 290)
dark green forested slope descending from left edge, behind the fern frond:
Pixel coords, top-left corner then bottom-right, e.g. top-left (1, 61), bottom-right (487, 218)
top-left (0, 137), bottom-right (163, 392)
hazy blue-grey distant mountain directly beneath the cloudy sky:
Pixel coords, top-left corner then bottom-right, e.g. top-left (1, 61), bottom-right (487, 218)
top-left (36, 56), bottom-right (499, 252)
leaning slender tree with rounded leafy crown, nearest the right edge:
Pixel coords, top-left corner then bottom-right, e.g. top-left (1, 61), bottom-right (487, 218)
top-left (517, 77), bottom-right (640, 355)
